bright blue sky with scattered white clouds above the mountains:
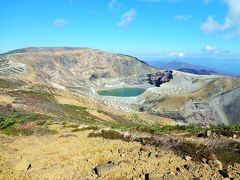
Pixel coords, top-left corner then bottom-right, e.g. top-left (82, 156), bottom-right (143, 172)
top-left (0, 0), bottom-right (240, 58)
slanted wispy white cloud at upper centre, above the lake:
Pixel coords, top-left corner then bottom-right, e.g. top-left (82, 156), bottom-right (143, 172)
top-left (117, 8), bottom-right (137, 27)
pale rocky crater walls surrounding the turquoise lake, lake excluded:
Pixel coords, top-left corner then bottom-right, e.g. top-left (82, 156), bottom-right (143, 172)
top-left (0, 48), bottom-right (240, 124)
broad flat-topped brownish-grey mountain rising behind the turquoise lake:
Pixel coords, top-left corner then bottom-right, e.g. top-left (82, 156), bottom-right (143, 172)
top-left (0, 48), bottom-right (156, 86)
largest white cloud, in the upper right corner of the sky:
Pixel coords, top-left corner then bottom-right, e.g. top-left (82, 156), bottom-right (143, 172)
top-left (201, 0), bottom-right (240, 39)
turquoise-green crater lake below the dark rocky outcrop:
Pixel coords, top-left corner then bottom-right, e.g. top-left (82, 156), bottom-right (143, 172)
top-left (97, 88), bottom-right (146, 97)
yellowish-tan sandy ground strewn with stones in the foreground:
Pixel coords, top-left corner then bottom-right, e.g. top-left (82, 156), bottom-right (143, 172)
top-left (0, 125), bottom-right (240, 180)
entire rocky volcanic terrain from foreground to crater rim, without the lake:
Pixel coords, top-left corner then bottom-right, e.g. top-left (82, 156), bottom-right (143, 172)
top-left (0, 48), bottom-right (240, 180)
